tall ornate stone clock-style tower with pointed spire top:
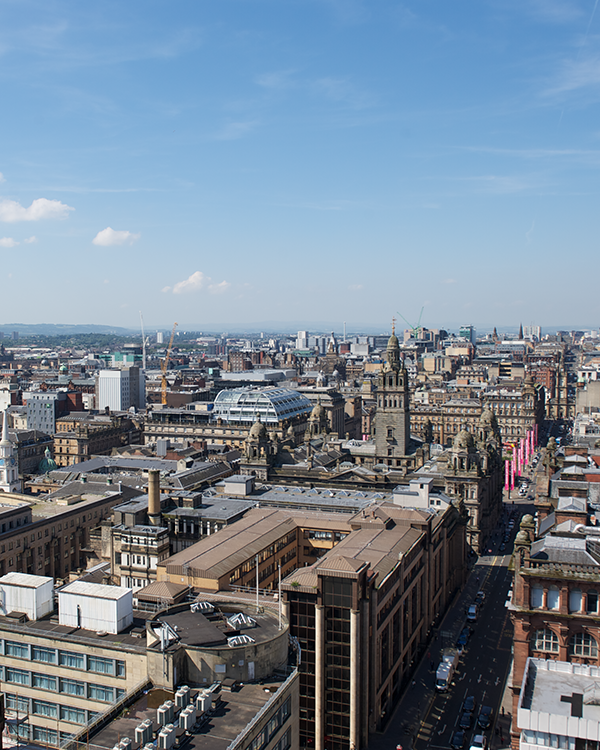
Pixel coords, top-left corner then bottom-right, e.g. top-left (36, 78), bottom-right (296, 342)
top-left (375, 329), bottom-right (410, 458)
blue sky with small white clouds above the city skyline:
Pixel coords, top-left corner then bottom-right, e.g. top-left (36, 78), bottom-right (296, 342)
top-left (0, 0), bottom-right (600, 329)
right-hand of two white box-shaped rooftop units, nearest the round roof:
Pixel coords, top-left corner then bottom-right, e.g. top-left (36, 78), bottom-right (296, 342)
top-left (58, 581), bottom-right (133, 633)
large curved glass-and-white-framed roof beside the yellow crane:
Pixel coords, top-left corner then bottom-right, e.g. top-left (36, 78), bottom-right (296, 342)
top-left (212, 388), bottom-right (313, 424)
